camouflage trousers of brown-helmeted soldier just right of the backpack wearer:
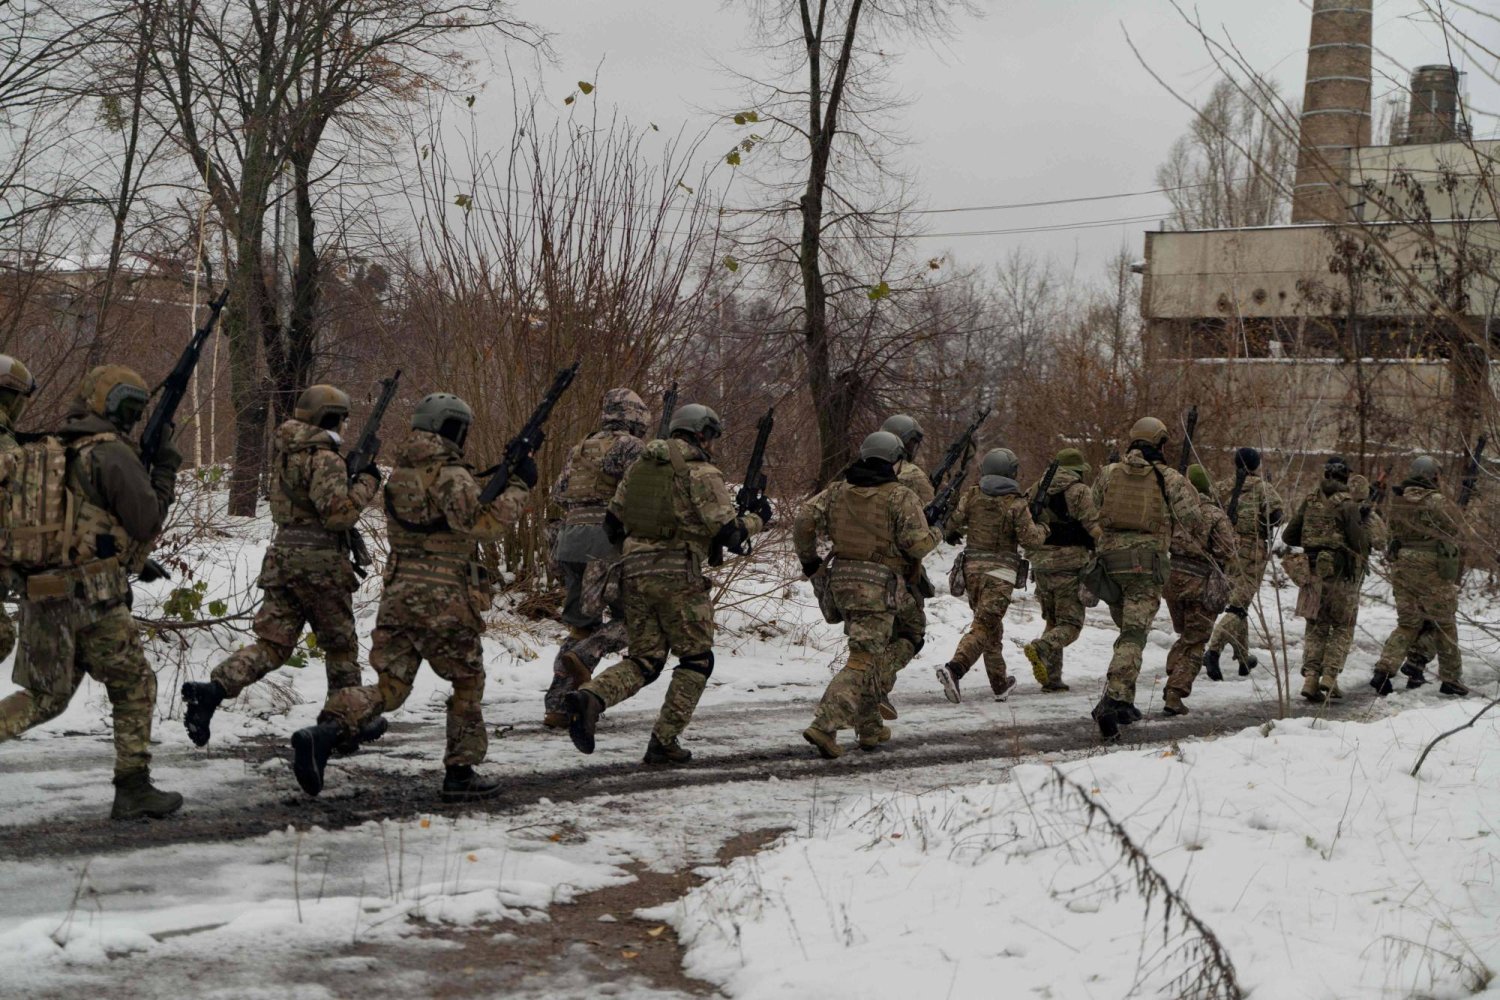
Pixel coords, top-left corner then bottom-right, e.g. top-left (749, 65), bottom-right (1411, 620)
top-left (212, 576), bottom-right (360, 697)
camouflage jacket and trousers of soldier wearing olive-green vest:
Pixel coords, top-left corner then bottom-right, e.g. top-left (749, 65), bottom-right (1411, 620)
top-left (579, 438), bottom-right (762, 748)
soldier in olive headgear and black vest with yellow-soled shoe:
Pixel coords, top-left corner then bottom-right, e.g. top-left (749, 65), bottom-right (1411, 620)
top-left (1023, 448), bottom-right (1103, 691)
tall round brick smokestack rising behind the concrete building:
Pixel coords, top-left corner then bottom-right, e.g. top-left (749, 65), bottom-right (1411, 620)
top-left (1292, 0), bottom-right (1373, 222)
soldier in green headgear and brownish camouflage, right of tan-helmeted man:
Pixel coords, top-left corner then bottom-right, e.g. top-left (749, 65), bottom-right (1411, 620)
top-left (1161, 465), bottom-right (1238, 715)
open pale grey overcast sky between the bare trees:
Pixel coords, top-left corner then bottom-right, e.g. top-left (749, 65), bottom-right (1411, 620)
top-left (498, 0), bottom-right (1500, 276)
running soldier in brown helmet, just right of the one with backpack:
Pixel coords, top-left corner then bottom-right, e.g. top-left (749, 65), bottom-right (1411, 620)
top-left (183, 385), bottom-right (380, 747)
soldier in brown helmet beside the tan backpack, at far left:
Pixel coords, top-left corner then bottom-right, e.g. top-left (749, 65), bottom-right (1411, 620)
top-left (0, 364), bottom-right (183, 820)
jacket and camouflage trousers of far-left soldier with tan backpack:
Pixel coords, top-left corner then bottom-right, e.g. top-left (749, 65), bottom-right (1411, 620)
top-left (0, 403), bottom-right (182, 779)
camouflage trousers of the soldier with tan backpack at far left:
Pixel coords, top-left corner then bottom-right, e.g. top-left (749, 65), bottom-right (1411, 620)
top-left (0, 601), bottom-right (156, 775)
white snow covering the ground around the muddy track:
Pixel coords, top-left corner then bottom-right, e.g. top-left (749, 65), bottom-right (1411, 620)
top-left (0, 488), bottom-right (1500, 997)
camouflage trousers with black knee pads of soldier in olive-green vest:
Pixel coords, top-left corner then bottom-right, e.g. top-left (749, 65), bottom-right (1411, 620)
top-left (581, 571), bottom-right (714, 744)
